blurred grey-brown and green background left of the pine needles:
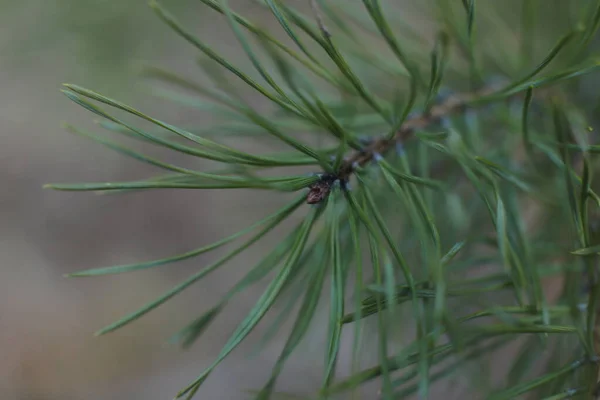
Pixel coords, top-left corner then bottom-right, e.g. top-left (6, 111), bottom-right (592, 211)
top-left (0, 0), bottom-right (342, 400)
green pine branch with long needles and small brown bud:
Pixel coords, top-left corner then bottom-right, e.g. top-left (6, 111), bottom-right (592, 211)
top-left (48, 0), bottom-right (600, 399)
